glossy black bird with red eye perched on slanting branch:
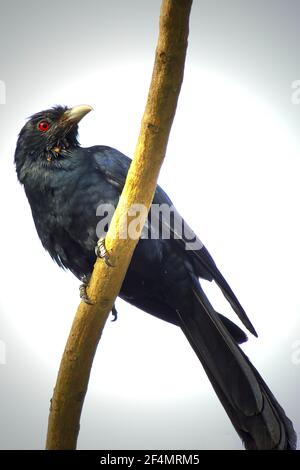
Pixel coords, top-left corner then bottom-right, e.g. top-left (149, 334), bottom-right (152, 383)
top-left (15, 106), bottom-right (296, 449)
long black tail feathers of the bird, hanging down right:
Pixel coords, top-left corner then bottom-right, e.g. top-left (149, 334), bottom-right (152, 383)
top-left (177, 285), bottom-right (296, 450)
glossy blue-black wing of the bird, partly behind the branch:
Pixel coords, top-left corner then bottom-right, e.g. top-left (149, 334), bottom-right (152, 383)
top-left (91, 146), bottom-right (257, 336)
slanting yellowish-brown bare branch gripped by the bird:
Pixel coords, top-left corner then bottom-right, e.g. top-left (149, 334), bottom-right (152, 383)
top-left (46, 0), bottom-right (192, 449)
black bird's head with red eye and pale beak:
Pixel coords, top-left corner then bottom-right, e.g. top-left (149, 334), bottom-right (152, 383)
top-left (15, 105), bottom-right (92, 181)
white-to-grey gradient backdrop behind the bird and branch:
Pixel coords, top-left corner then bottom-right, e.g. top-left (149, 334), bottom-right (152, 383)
top-left (0, 0), bottom-right (300, 449)
